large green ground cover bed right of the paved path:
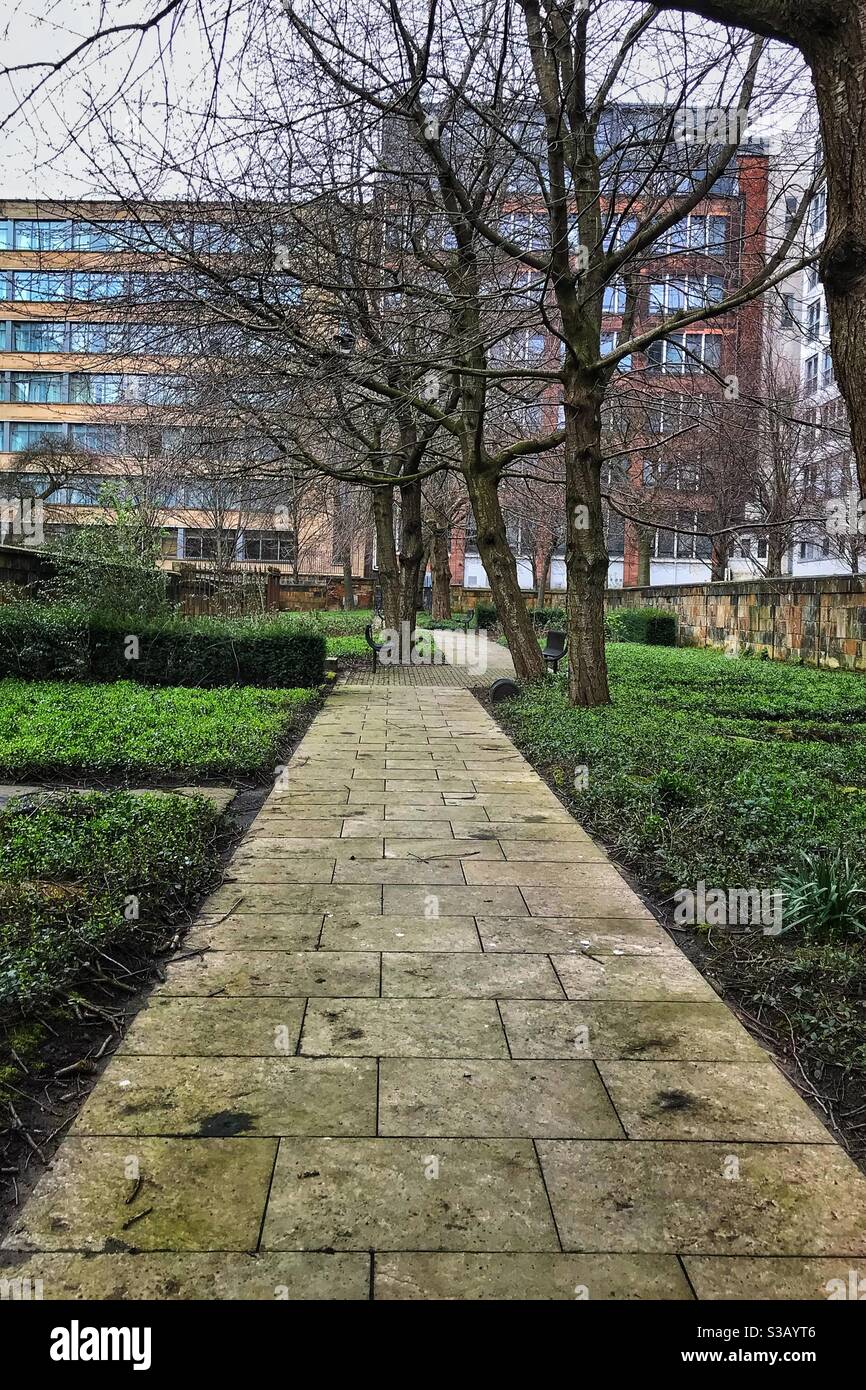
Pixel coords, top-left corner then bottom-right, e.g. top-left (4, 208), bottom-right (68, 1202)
top-left (502, 644), bottom-right (866, 1074)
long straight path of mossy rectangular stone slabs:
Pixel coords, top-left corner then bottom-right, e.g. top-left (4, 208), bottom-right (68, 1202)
top-left (7, 687), bottom-right (866, 1300)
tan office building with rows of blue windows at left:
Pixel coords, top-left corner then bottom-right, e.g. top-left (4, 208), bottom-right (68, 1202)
top-left (0, 200), bottom-right (368, 577)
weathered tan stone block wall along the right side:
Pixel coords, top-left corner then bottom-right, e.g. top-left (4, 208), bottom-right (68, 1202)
top-left (606, 575), bottom-right (866, 671)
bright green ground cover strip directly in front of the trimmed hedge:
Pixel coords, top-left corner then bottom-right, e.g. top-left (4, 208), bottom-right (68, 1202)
top-left (0, 680), bottom-right (317, 781)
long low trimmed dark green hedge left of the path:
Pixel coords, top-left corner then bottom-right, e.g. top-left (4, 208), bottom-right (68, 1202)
top-left (0, 603), bottom-right (325, 689)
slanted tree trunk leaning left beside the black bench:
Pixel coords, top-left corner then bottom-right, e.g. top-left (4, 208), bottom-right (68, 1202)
top-left (466, 468), bottom-right (545, 681)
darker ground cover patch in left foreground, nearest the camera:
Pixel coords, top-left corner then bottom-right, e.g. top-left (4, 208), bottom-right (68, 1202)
top-left (0, 791), bottom-right (222, 1086)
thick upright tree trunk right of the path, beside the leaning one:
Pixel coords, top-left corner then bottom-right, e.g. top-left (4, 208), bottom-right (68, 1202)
top-left (566, 382), bottom-right (610, 708)
